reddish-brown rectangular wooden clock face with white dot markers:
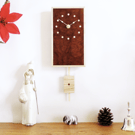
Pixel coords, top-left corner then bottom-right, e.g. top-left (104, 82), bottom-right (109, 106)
top-left (53, 8), bottom-right (84, 66)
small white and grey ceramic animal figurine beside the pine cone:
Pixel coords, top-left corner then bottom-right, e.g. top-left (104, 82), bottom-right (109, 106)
top-left (63, 115), bottom-right (78, 125)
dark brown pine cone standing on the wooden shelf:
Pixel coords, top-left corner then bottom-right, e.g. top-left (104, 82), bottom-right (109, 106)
top-left (98, 107), bottom-right (113, 126)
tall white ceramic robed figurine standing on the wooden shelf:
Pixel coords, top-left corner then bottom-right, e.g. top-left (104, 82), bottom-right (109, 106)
top-left (19, 63), bottom-right (37, 126)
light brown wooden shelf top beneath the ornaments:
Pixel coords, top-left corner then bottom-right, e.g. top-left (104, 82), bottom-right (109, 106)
top-left (0, 123), bottom-right (135, 135)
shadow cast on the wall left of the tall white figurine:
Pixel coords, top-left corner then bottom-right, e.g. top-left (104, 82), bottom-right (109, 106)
top-left (6, 65), bottom-right (26, 123)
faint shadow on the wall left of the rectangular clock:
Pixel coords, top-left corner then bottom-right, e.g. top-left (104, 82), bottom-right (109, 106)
top-left (41, 12), bottom-right (52, 67)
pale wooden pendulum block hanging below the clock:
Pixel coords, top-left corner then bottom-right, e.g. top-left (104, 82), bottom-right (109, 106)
top-left (64, 76), bottom-right (74, 93)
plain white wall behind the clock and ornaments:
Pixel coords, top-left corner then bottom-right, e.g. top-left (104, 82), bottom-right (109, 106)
top-left (0, 0), bottom-right (135, 122)
